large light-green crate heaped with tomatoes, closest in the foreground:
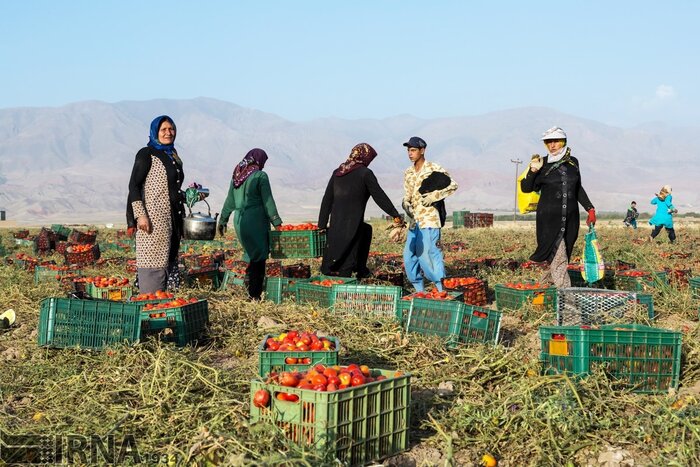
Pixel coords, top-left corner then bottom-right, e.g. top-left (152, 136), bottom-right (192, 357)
top-left (250, 364), bottom-right (411, 466)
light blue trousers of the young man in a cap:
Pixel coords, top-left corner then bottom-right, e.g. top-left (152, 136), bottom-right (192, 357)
top-left (403, 225), bottom-right (445, 292)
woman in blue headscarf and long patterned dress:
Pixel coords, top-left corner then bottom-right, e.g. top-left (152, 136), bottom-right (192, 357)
top-left (127, 115), bottom-right (185, 293)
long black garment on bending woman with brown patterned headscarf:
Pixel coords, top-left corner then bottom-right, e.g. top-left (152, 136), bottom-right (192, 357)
top-left (318, 167), bottom-right (399, 271)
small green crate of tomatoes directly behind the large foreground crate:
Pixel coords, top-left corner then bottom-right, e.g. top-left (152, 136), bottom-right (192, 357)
top-left (258, 330), bottom-right (340, 377)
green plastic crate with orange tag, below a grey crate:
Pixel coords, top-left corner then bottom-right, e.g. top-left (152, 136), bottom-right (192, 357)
top-left (540, 324), bottom-right (682, 393)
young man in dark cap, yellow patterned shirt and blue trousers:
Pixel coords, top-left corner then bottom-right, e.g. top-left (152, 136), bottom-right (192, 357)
top-left (402, 136), bottom-right (457, 292)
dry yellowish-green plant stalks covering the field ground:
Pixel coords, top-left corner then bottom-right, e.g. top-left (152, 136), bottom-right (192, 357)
top-left (0, 227), bottom-right (700, 466)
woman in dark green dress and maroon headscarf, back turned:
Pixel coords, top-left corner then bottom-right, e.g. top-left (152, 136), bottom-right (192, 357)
top-left (218, 148), bottom-right (282, 300)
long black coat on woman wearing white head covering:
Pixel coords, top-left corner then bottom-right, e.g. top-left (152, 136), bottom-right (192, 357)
top-left (520, 156), bottom-right (593, 261)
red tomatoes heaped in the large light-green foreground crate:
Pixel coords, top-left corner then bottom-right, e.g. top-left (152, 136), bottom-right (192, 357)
top-left (253, 363), bottom-right (403, 408)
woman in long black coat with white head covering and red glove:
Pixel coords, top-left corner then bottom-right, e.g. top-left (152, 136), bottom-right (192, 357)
top-left (520, 127), bottom-right (596, 288)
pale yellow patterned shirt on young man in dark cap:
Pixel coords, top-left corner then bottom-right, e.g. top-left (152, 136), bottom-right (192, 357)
top-left (401, 161), bottom-right (457, 229)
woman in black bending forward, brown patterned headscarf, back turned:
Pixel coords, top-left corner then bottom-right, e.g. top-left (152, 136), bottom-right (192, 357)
top-left (318, 143), bottom-right (403, 278)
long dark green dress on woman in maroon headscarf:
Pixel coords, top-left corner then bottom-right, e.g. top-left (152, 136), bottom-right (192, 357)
top-left (220, 170), bottom-right (282, 262)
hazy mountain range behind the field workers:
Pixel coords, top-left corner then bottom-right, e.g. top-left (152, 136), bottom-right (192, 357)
top-left (0, 98), bottom-right (700, 224)
